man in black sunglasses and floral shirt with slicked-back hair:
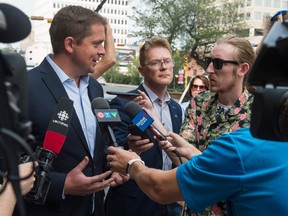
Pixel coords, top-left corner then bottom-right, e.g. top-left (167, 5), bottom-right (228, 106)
top-left (180, 36), bottom-right (255, 215)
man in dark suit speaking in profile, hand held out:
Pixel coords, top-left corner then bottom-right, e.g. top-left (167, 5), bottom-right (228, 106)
top-left (26, 6), bottom-right (120, 216)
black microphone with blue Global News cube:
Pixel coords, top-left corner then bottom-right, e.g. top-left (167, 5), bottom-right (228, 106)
top-left (124, 101), bottom-right (167, 141)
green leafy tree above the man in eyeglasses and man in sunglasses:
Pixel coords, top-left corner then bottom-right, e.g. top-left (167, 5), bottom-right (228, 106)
top-left (131, 0), bottom-right (246, 65)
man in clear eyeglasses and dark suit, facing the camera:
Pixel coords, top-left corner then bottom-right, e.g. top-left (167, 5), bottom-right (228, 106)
top-left (105, 37), bottom-right (182, 216)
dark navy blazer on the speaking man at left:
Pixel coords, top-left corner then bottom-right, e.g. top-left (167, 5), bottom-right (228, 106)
top-left (26, 59), bottom-right (106, 216)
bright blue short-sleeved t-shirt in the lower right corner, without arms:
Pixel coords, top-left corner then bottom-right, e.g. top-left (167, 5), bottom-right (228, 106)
top-left (176, 128), bottom-right (288, 216)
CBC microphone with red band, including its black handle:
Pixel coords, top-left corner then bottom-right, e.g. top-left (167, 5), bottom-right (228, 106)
top-left (20, 98), bottom-right (73, 205)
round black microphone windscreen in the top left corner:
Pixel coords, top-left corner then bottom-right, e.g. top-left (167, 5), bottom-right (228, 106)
top-left (0, 3), bottom-right (31, 43)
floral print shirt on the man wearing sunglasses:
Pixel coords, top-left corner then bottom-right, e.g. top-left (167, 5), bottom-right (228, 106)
top-left (180, 89), bottom-right (254, 151)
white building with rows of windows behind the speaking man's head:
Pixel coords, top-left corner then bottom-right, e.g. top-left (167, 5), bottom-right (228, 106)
top-left (25, 0), bottom-right (132, 67)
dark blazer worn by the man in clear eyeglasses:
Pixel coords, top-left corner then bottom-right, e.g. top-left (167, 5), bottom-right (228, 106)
top-left (105, 85), bottom-right (182, 216)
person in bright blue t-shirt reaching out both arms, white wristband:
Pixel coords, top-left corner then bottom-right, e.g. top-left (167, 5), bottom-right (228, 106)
top-left (107, 128), bottom-right (288, 216)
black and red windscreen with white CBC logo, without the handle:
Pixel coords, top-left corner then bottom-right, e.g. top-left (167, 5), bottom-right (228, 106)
top-left (43, 98), bottom-right (73, 154)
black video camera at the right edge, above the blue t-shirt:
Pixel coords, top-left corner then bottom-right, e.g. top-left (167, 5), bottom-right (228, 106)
top-left (248, 19), bottom-right (288, 141)
